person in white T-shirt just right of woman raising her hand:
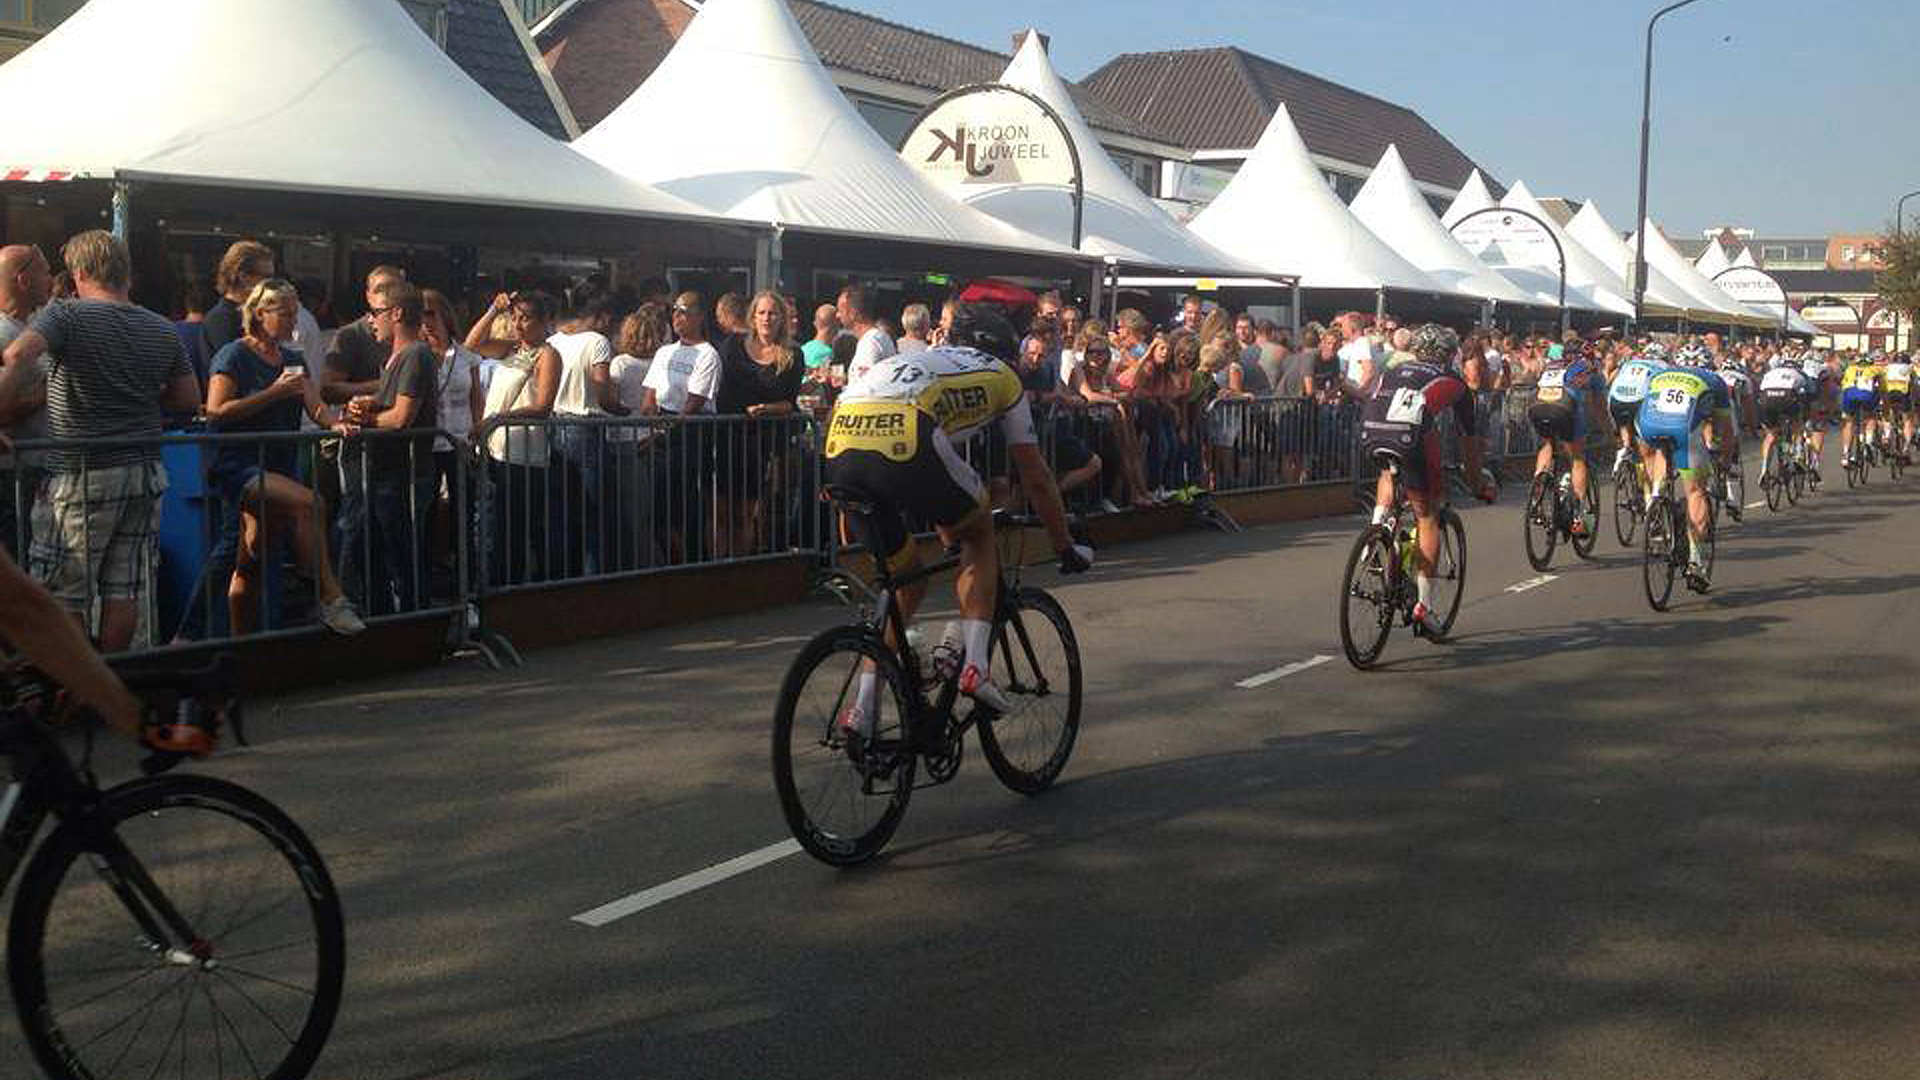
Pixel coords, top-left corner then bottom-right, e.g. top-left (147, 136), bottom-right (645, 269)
top-left (547, 290), bottom-right (626, 577)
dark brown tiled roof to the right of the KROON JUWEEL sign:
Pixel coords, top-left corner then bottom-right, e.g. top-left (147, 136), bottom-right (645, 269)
top-left (1083, 48), bottom-right (1492, 188)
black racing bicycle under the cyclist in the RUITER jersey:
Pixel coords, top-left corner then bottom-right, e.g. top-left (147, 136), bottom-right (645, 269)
top-left (772, 484), bottom-right (1081, 867)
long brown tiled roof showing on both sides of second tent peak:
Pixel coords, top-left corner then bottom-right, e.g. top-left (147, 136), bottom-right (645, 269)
top-left (540, 0), bottom-right (1169, 142)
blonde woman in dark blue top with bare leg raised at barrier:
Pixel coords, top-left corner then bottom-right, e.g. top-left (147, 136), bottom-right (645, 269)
top-left (207, 279), bottom-right (367, 634)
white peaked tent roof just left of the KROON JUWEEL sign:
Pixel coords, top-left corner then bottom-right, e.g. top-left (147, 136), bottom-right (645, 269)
top-left (574, 0), bottom-right (1077, 256)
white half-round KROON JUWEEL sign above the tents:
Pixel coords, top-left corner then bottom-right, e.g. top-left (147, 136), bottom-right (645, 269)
top-left (900, 86), bottom-right (1079, 196)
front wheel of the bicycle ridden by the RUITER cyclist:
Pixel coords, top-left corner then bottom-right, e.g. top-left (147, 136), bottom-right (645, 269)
top-left (979, 588), bottom-right (1081, 796)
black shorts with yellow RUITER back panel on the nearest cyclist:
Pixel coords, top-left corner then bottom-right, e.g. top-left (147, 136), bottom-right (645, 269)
top-left (828, 402), bottom-right (987, 569)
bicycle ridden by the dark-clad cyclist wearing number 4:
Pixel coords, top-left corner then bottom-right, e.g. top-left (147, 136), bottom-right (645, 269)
top-left (1340, 450), bottom-right (1467, 671)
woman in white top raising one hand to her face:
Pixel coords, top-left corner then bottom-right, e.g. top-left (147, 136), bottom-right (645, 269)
top-left (467, 292), bottom-right (561, 584)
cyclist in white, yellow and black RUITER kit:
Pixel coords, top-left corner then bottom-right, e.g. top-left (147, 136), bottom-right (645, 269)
top-left (826, 297), bottom-right (1092, 734)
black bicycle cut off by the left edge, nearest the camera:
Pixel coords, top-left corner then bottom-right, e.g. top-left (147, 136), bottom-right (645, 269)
top-left (0, 659), bottom-right (346, 1080)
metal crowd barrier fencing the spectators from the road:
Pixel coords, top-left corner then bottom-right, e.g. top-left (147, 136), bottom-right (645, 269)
top-left (0, 388), bottom-right (1538, 668)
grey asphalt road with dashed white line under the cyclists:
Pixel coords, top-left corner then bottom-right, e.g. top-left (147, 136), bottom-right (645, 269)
top-left (0, 453), bottom-right (1920, 1080)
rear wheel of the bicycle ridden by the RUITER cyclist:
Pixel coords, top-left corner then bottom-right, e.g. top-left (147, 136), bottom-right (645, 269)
top-left (774, 626), bottom-right (916, 867)
